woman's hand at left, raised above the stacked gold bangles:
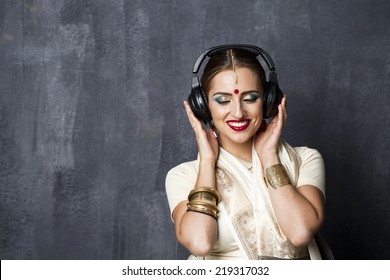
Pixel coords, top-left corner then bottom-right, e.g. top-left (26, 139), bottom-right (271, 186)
top-left (184, 101), bottom-right (219, 163)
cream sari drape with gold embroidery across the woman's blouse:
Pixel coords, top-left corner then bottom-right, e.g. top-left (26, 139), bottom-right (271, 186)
top-left (217, 142), bottom-right (321, 259)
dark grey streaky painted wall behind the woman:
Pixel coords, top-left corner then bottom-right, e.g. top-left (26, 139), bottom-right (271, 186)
top-left (0, 0), bottom-right (390, 259)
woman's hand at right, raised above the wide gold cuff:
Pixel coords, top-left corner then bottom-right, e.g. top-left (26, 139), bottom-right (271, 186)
top-left (254, 96), bottom-right (287, 166)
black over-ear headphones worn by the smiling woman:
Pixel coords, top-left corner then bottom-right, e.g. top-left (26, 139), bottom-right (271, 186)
top-left (188, 44), bottom-right (283, 127)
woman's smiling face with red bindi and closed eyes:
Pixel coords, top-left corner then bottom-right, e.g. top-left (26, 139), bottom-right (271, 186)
top-left (208, 68), bottom-right (263, 149)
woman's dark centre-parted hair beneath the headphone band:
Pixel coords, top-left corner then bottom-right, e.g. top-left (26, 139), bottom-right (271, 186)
top-left (201, 49), bottom-right (266, 94)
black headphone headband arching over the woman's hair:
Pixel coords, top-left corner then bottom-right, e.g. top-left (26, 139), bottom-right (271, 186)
top-left (192, 44), bottom-right (276, 75)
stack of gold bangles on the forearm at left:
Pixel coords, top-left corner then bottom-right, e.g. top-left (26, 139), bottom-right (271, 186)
top-left (187, 187), bottom-right (221, 219)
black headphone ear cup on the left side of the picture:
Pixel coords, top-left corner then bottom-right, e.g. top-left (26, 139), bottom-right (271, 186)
top-left (188, 82), bottom-right (212, 125)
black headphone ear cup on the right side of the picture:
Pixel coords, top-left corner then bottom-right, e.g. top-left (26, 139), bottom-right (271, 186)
top-left (263, 72), bottom-right (283, 119)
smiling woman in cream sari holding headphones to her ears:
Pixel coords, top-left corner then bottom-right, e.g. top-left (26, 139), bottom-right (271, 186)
top-left (166, 45), bottom-right (325, 259)
